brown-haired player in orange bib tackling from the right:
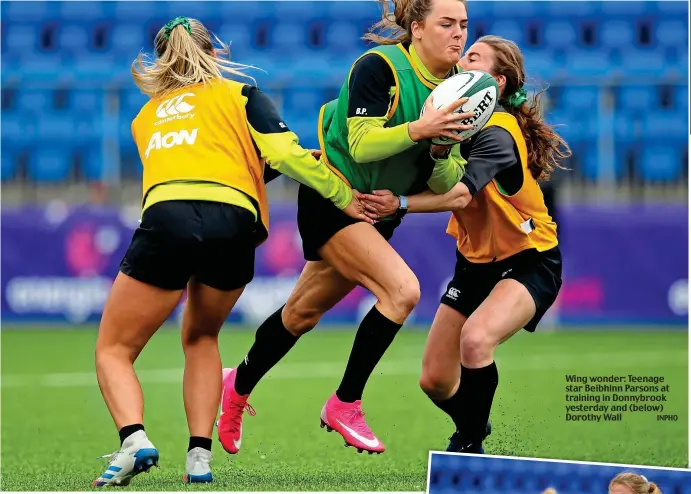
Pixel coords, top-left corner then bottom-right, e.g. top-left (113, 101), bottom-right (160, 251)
top-left (360, 36), bottom-right (570, 453)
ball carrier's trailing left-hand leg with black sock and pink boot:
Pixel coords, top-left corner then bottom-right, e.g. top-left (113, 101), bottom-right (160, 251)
top-left (218, 261), bottom-right (355, 454)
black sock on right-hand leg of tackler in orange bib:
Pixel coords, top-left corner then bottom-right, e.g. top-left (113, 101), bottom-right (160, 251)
top-left (452, 362), bottom-right (499, 442)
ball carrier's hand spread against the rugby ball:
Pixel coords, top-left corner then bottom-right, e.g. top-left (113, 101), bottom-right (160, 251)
top-left (408, 95), bottom-right (473, 142)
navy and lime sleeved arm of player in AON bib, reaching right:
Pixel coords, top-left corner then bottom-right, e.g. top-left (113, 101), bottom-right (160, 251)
top-left (242, 86), bottom-right (353, 209)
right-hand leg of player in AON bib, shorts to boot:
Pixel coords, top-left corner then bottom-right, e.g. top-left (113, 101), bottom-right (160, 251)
top-left (182, 202), bottom-right (255, 474)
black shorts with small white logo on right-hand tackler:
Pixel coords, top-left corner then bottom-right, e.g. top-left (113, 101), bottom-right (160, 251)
top-left (441, 246), bottom-right (562, 333)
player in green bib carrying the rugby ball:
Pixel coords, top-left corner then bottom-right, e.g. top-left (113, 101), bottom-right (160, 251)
top-left (218, 0), bottom-right (472, 453)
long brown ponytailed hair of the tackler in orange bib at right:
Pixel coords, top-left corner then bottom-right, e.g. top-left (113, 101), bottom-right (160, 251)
top-left (476, 36), bottom-right (571, 181)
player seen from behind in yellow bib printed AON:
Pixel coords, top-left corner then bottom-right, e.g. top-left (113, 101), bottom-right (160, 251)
top-left (94, 17), bottom-right (371, 486)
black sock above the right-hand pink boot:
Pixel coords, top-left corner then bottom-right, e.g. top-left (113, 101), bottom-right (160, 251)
top-left (336, 306), bottom-right (402, 403)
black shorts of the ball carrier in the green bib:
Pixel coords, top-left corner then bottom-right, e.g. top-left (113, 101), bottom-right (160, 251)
top-left (298, 184), bottom-right (401, 261)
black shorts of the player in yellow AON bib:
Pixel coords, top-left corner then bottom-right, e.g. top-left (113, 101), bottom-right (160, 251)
top-left (120, 201), bottom-right (256, 291)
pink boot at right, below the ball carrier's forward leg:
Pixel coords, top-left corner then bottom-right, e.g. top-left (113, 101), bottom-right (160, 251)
top-left (321, 393), bottom-right (386, 454)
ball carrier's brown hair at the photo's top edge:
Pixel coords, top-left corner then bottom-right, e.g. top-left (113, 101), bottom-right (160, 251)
top-left (362, 0), bottom-right (468, 45)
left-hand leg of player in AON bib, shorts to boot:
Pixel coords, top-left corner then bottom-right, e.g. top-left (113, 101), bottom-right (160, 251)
top-left (94, 202), bottom-right (191, 486)
